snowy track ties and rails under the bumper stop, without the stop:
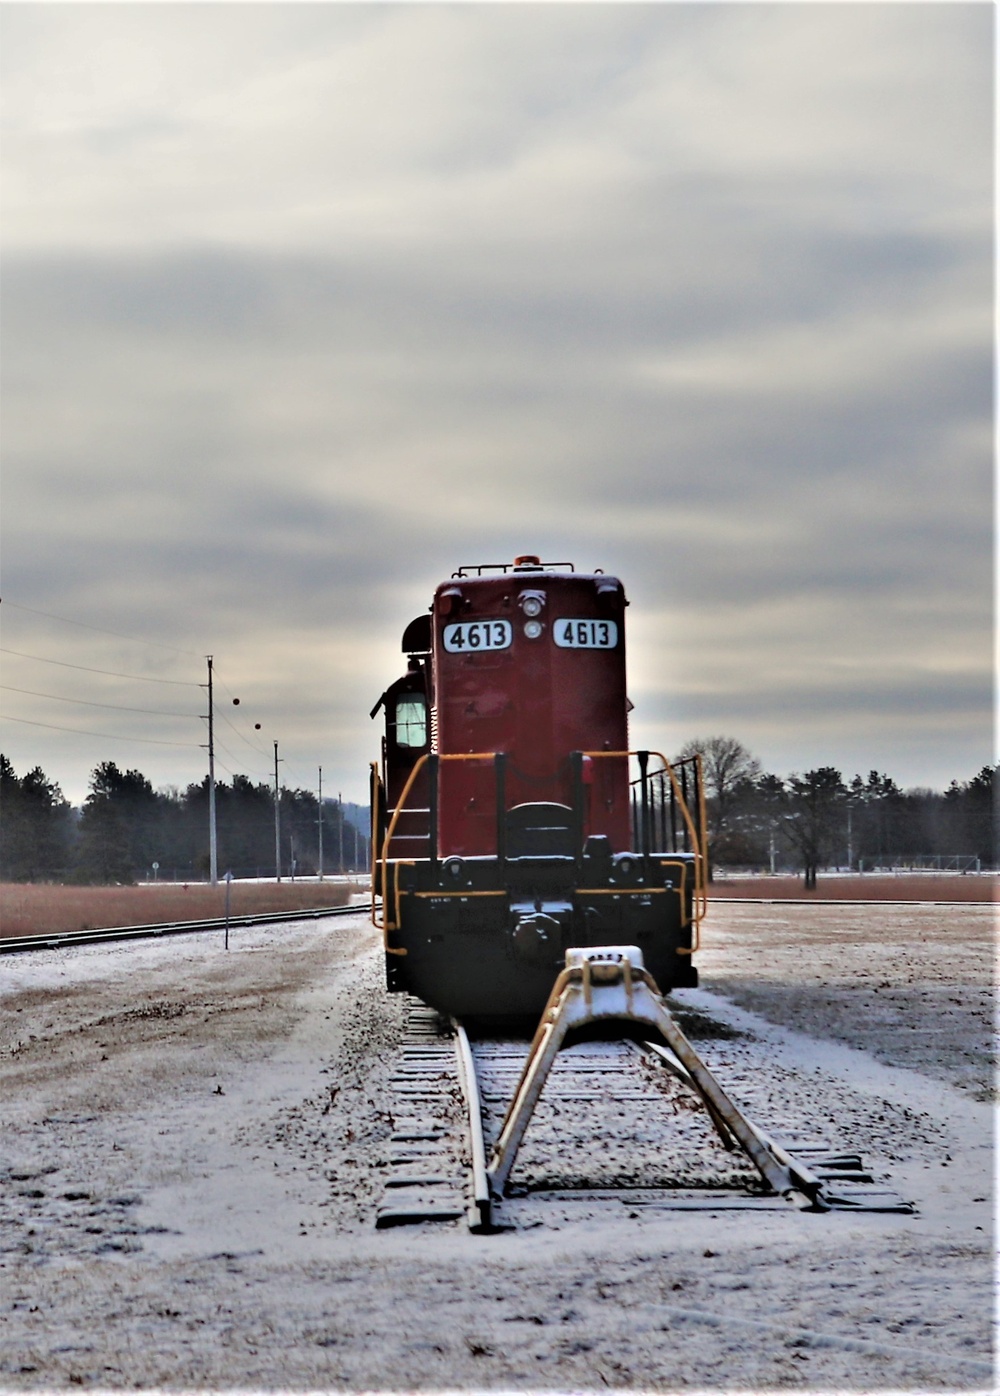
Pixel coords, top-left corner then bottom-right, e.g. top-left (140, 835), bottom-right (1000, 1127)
top-left (376, 982), bottom-right (913, 1231)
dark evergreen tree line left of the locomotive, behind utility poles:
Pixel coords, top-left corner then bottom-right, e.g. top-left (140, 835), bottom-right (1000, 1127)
top-left (0, 755), bottom-right (369, 884)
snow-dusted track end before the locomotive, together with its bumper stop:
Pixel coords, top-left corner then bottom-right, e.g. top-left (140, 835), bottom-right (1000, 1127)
top-left (377, 948), bottom-right (912, 1231)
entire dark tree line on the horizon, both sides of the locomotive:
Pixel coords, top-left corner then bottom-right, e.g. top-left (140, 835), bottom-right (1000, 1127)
top-left (0, 736), bottom-right (997, 885)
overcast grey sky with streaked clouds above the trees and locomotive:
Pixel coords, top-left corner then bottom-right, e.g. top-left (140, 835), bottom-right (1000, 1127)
top-left (0, 3), bottom-right (994, 801)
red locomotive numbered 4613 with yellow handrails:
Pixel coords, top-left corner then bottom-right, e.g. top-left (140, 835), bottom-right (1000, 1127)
top-left (372, 557), bottom-right (704, 1018)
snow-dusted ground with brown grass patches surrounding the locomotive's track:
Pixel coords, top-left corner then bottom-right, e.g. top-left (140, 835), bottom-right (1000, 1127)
top-left (0, 905), bottom-right (993, 1392)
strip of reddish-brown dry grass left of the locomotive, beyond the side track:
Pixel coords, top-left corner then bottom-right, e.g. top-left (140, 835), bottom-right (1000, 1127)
top-left (0, 882), bottom-right (355, 937)
